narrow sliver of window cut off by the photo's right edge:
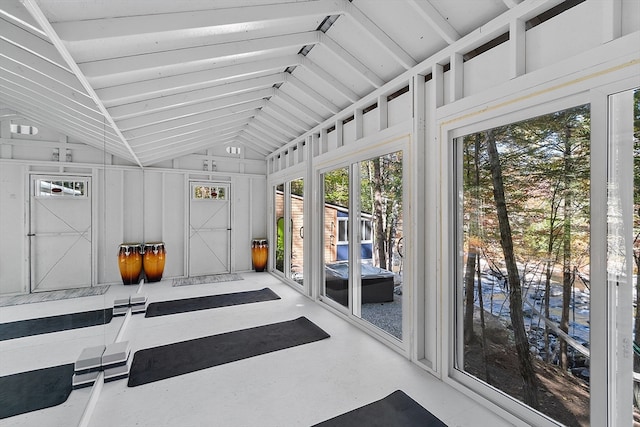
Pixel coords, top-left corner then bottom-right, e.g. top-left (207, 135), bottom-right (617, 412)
top-left (607, 89), bottom-right (640, 425)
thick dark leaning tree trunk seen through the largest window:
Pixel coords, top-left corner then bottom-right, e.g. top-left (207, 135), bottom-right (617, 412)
top-left (487, 130), bottom-right (538, 409)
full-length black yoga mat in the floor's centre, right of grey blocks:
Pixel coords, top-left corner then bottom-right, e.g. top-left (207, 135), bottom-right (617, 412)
top-left (129, 317), bottom-right (329, 387)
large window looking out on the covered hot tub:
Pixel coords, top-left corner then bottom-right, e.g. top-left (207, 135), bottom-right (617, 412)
top-left (322, 151), bottom-right (404, 340)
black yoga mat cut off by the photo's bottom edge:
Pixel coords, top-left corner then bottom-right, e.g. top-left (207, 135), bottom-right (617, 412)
top-left (313, 390), bottom-right (447, 427)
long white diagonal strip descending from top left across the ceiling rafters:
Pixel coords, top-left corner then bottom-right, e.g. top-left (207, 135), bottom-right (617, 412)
top-left (21, 0), bottom-right (143, 168)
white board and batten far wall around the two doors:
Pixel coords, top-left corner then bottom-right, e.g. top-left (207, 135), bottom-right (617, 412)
top-left (0, 132), bottom-right (267, 295)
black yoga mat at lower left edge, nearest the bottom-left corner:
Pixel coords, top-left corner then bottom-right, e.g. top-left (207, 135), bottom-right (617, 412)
top-left (0, 363), bottom-right (73, 419)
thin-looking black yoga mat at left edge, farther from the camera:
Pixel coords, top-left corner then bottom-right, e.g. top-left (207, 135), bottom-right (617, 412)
top-left (0, 308), bottom-right (113, 341)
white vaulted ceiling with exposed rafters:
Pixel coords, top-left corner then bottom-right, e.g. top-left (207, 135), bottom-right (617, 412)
top-left (0, 0), bottom-right (520, 166)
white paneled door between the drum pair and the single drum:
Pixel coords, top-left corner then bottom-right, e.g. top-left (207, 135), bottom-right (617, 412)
top-left (189, 182), bottom-right (231, 277)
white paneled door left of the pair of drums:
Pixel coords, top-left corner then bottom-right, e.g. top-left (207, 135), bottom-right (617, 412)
top-left (29, 175), bottom-right (92, 292)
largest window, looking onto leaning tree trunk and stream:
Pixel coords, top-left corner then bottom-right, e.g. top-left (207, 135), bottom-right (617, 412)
top-left (455, 106), bottom-right (595, 426)
